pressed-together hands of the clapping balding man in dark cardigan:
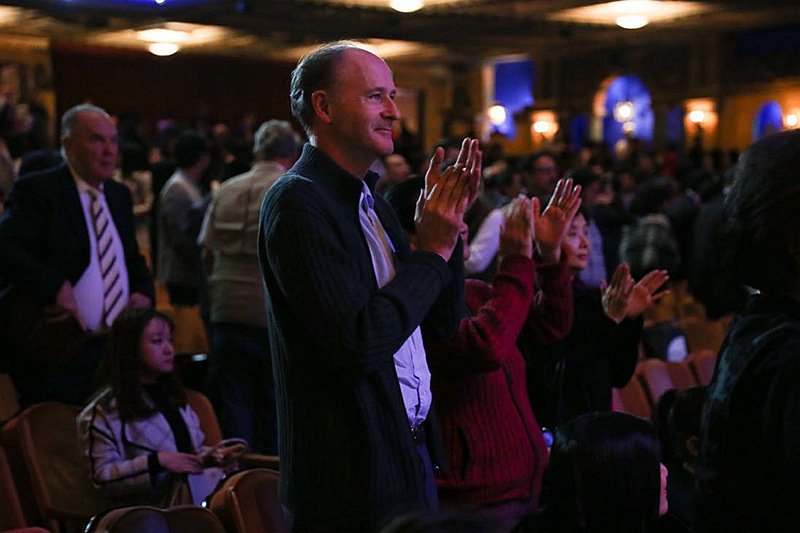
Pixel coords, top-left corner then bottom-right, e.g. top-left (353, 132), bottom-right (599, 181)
top-left (414, 139), bottom-right (481, 261)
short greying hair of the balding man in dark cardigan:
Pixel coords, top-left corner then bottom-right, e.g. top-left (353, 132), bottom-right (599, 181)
top-left (289, 41), bottom-right (361, 136)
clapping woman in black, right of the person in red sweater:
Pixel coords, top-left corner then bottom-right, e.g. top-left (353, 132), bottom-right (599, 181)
top-left (519, 207), bottom-right (668, 428)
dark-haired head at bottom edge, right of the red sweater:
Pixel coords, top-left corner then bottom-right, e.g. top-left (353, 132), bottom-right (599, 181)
top-left (541, 412), bottom-right (661, 532)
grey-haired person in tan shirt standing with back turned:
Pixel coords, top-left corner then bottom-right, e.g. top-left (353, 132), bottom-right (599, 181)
top-left (199, 120), bottom-right (301, 455)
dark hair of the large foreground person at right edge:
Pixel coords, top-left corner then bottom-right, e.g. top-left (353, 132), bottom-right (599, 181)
top-left (725, 130), bottom-right (800, 293)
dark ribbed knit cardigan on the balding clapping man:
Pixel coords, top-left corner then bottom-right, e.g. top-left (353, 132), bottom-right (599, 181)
top-left (258, 144), bottom-right (465, 532)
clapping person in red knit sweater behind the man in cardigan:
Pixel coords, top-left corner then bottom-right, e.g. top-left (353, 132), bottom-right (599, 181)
top-left (387, 179), bottom-right (580, 526)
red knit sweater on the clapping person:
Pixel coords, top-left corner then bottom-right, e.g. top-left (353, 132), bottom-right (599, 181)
top-left (426, 256), bottom-right (572, 507)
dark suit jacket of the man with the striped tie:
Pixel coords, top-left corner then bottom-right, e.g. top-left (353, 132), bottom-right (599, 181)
top-left (0, 164), bottom-right (154, 309)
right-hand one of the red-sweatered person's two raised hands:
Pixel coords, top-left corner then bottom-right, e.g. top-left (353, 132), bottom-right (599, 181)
top-left (533, 179), bottom-right (581, 263)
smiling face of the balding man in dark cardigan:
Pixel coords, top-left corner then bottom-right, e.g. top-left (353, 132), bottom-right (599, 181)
top-left (329, 50), bottom-right (400, 160)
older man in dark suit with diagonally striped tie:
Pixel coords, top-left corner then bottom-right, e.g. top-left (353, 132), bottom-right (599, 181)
top-left (0, 104), bottom-right (153, 404)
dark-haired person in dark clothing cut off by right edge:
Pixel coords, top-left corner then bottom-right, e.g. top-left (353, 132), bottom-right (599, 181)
top-left (697, 130), bottom-right (800, 532)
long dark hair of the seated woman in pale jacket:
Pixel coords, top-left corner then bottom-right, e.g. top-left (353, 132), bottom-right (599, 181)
top-left (98, 307), bottom-right (186, 418)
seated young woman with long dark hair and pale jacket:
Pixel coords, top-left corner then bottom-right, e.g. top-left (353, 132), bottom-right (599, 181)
top-left (78, 308), bottom-right (231, 509)
